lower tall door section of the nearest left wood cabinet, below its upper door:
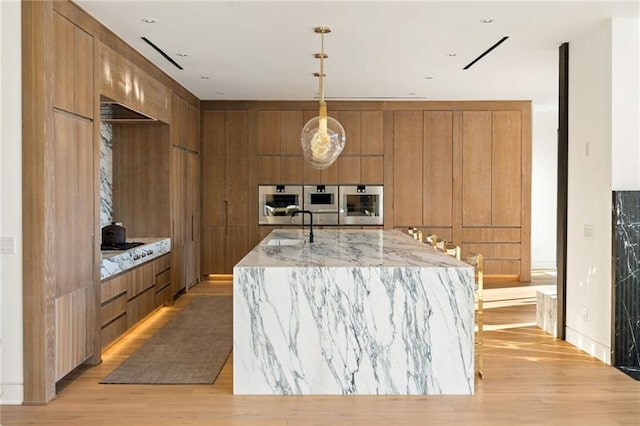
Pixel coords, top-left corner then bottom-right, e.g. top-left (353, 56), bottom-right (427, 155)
top-left (49, 110), bottom-right (95, 380)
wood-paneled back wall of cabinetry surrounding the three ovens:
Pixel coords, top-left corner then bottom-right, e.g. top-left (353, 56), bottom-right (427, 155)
top-left (201, 101), bottom-right (531, 281)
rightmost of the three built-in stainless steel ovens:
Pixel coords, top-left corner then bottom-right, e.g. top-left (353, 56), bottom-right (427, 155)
top-left (339, 185), bottom-right (384, 225)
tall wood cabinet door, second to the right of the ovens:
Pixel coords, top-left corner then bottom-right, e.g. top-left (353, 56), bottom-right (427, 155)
top-left (422, 111), bottom-right (453, 227)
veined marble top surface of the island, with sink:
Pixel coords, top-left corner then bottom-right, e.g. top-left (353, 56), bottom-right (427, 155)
top-left (236, 229), bottom-right (470, 268)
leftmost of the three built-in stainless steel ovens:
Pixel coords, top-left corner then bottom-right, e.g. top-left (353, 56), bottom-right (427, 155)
top-left (258, 185), bottom-right (302, 225)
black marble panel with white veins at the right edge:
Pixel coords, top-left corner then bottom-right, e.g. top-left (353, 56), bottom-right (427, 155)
top-left (613, 191), bottom-right (640, 380)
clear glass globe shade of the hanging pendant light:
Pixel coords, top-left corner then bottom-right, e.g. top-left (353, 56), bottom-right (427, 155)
top-left (300, 115), bottom-right (347, 170)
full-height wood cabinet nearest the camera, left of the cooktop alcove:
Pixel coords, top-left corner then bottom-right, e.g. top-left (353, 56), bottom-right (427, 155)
top-left (49, 12), bottom-right (96, 380)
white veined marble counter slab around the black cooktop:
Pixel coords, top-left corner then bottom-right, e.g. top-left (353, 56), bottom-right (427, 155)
top-left (100, 238), bottom-right (171, 280)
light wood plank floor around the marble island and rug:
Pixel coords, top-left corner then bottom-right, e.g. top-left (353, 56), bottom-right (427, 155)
top-left (0, 282), bottom-right (640, 426)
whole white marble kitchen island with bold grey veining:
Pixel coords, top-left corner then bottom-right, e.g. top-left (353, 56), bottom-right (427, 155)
top-left (233, 230), bottom-right (474, 395)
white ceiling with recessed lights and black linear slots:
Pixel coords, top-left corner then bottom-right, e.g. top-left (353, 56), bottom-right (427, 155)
top-left (76, 0), bottom-right (639, 107)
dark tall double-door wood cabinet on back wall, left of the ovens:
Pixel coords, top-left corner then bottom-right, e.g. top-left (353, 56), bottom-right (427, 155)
top-left (202, 111), bottom-right (249, 274)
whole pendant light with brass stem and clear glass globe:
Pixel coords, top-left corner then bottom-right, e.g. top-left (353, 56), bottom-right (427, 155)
top-left (300, 27), bottom-right (347, 169)
